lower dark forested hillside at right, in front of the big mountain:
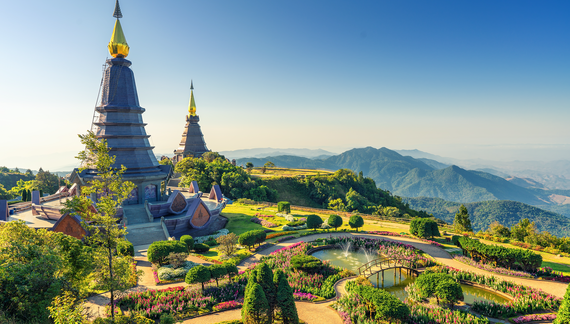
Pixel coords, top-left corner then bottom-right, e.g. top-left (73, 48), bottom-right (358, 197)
top-left (402, 197), bottom-right (570, 236)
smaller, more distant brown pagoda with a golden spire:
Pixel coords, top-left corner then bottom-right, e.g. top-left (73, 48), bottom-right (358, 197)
top-left (173, 82), bottom-right (210, 162)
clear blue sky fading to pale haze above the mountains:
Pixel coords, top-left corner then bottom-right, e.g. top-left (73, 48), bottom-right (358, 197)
top-left (0, 0), bottom-right (570, 171)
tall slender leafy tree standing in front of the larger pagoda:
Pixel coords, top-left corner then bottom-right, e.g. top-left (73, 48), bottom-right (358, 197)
top-left (64, 132), bottom-right (135, 321)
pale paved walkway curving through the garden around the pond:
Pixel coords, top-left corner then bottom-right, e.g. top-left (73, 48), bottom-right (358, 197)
top-left (88, 233), bottom-right (568, 324)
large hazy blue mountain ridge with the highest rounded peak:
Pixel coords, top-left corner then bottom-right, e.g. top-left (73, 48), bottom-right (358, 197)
top-left (237, 147), bottom-right (564, 205)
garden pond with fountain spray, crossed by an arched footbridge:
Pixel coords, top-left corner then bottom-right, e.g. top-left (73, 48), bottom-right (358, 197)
top-left (312, 249), bottom-right (508, 304)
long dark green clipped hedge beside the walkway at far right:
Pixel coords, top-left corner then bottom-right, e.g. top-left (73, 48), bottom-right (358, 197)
top-left (458, 237), bottom-right (542, 272)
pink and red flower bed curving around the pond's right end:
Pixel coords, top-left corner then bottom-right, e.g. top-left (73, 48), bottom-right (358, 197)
top-left (428, 266), bottom-right (562, 318)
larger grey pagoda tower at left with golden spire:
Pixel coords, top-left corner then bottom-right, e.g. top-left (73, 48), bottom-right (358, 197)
top-left (71, 0), bottom-right (171, 204)
